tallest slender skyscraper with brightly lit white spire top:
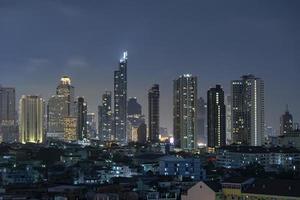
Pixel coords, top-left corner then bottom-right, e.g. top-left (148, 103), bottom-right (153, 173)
top-left (114, 52), bottom-right (127, 144)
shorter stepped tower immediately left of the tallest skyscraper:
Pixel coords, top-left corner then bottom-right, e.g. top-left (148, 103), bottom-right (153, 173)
top-left (98, 91), bottom-right (114, 141)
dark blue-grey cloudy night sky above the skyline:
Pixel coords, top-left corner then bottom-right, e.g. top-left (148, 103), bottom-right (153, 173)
top-left (0, 0), bottom-right (300, 134)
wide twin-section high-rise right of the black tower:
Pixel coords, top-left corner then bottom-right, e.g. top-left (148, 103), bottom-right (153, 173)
top-left (231, 75), bottom-right (265, 146)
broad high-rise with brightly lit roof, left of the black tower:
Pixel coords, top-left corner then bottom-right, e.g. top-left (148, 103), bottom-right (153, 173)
top-left (173, 74), bottom-right (197, 150)
